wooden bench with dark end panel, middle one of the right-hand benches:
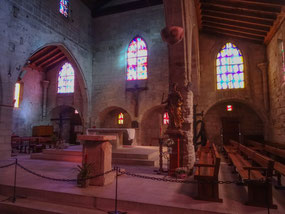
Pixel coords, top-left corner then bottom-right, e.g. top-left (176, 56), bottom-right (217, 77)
top-left (222, 140), bottom-right (277, 208)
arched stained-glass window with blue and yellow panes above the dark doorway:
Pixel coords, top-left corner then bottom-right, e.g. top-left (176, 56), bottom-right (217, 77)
top-left (217, 42), bottom-right (244, 89)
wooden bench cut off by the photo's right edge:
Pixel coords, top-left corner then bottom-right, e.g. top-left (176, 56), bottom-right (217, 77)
top-left (244, 140), bottom-right (285, 189)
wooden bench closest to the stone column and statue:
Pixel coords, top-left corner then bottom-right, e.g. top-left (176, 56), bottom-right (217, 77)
top-left (194, 142), bottom-right (223, 202)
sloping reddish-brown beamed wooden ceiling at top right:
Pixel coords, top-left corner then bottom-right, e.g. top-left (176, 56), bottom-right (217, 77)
top-left (195, 0), bottom-right (285, 44)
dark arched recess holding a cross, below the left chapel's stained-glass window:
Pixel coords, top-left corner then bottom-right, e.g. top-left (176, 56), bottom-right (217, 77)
top-left (49, 106), bottom-right (83, 144)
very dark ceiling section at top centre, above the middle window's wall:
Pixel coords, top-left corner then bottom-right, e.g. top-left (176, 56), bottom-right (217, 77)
top-left (81, 0), bottom-right (163, 17)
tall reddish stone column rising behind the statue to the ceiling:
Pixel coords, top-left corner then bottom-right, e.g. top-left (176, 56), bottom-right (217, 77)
top-left (162, 0), bottom-right (195, 169)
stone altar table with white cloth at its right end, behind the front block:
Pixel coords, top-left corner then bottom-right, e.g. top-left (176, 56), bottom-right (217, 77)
top-left (86, 128), bottom-right (136, 150)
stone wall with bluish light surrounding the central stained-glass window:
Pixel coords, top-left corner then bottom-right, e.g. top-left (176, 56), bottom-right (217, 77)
top-left (92, 5), bottom-right (168, 144)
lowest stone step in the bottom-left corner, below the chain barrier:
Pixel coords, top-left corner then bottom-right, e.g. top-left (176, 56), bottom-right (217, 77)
top-left (0, 196), bottom-right (106, 214)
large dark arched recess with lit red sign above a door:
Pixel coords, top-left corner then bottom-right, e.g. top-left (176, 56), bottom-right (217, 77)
top-left (204, 100), bottom-right (264, 144)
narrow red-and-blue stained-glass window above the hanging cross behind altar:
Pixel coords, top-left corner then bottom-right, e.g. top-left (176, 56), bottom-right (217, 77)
top-left (127, 37), bottom-right (147, 80)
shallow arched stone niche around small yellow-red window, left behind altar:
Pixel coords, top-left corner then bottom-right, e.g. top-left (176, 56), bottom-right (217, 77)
top-left (99, 106), bottom-right (132, 128)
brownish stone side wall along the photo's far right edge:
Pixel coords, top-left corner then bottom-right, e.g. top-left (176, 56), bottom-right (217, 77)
top-left (267, 22), bottom-right (285, 143)
